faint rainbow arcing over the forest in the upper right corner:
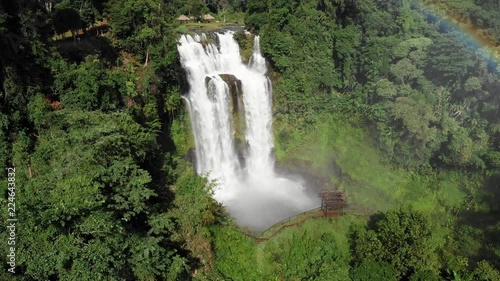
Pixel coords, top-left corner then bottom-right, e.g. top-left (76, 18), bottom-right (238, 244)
top-left (410, 0), bottom-right (500, 68)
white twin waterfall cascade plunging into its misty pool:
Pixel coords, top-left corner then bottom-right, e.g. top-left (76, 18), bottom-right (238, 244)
top-left (178, 31), bottom-right (317, 230)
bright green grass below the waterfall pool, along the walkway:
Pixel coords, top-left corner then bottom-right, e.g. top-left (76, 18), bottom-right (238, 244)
top-left (207, 214), bottom-right (367, 280)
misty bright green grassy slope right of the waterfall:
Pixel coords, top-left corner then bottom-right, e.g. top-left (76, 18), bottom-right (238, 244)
top-left (275, 114), bottom-right (470, 213)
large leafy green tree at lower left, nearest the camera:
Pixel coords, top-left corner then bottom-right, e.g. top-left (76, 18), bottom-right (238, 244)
top-left (17, 109), bottom-right (188, 280)
